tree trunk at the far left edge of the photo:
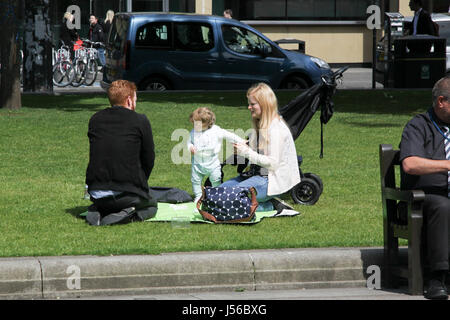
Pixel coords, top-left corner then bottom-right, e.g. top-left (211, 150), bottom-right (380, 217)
top-left (0, 0), bottom-right (22, 109)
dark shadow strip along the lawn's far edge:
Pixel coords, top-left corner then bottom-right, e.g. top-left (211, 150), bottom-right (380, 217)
top-left (22, 89), bottom-right (431, 115)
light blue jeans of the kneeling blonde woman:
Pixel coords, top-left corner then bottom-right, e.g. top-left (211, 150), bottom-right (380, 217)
top-left (220, 176), bottom-right (274, 211)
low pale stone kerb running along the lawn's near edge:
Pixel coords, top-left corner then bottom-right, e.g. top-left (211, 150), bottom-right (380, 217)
top-left (0, 248), bottom-right (423, 300)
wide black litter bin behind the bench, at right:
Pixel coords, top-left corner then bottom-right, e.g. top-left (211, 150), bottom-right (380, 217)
top-left (393, 35), bottom-right (446, 88)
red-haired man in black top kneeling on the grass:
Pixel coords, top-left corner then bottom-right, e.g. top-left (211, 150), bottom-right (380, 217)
top-left (86, 80), bottom-right (157, 225)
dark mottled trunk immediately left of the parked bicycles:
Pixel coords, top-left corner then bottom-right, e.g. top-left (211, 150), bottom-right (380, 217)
top-left (23, 0), bottom-right (53, 92)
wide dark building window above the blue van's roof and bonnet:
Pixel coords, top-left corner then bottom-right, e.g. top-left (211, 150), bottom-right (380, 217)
top-left (224, 0), bottom-right (381, 20)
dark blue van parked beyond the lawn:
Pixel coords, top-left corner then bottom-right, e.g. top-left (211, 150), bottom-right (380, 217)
top-left (102, 12), bottom-right (331, 91)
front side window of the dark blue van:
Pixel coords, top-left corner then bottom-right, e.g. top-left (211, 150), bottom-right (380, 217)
top-left (222, 25), bottom-right (273, 56)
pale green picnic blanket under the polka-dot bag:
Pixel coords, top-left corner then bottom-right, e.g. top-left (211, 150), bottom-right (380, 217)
top-left (80, 202), bottom-right (300, 224)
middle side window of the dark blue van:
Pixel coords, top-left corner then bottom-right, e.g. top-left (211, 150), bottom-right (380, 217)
top-left (174, 22), bottom-right (214, 51)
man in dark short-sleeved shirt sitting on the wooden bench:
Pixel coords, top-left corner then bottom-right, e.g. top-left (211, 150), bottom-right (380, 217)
top-left (400, 77), bottom-right (450, 299)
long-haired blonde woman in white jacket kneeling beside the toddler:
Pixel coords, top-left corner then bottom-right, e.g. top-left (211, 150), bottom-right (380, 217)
top-left (221, 83), bottom-right (300, 212)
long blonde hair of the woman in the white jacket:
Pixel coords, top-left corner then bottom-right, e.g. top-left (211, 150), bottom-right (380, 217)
top-left (247, 82), bottom-right (280, 151)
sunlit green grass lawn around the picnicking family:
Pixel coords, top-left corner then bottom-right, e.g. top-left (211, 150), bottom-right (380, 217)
top-left (0, 90), bottom-right (431, 257)
